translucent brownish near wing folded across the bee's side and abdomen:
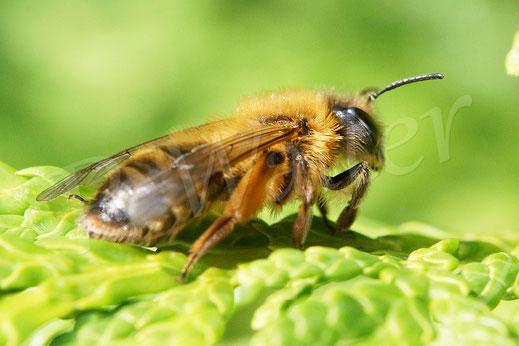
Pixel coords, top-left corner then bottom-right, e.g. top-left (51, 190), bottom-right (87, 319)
top-left (129, 125), bottom-right (298, 220)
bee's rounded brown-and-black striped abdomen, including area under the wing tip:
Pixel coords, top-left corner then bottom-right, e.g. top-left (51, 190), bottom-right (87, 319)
top-left (82, 147), bottom-right (211, 245)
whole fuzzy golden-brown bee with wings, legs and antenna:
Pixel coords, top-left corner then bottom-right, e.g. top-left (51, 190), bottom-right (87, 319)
top-left (37, 73), bottom-right (443, 280)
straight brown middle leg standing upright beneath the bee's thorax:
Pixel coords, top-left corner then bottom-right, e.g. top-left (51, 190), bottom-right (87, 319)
top-left (292, 155), bottom-right (317, 249)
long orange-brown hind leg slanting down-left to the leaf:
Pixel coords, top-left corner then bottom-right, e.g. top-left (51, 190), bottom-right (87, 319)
top-left (179, 151), bottom-right (285, 282)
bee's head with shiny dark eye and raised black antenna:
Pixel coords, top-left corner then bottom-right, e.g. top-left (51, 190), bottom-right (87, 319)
top-left (332, 73), bottom-right (443, 170)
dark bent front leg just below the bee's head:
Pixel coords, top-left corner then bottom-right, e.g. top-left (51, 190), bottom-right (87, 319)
top-left (324, 161), bottom-right (370, 231)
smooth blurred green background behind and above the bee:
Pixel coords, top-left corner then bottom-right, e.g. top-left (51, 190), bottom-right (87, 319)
top-left (0, 0), bottom-right (519, 233)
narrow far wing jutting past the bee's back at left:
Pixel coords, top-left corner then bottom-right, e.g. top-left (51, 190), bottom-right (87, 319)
top-left (36, 135), bottom-right (170, 202)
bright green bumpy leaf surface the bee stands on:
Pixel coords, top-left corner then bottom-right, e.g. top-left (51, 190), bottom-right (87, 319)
top-left (0, 164), bottom-right (519, 345)
